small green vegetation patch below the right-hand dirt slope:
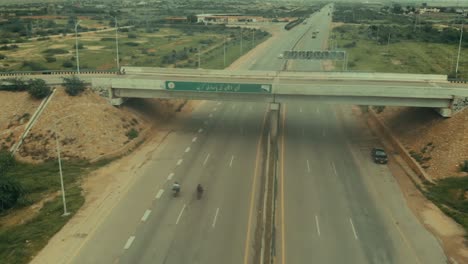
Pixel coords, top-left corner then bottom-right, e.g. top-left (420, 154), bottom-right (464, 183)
top-left (424, 177), bottom-right (468, 235)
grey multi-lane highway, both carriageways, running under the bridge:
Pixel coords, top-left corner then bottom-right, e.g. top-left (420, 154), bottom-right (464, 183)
top-left (63, 2), bottom-right (445, 264)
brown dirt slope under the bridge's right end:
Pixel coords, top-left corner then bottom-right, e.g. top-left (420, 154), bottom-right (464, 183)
top-left (378, 107), bottom-right (468, 179)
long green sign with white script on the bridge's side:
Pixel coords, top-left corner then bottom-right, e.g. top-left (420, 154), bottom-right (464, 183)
top-left (164, 81), bottom-right (271, 93)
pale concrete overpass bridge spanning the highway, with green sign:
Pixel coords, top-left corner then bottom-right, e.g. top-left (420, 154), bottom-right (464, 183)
top-left (91, 67), bottom-right (468, 117)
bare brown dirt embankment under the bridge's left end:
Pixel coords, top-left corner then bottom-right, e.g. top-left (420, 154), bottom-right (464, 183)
top-left (0, 88), bottom-right (190, 162)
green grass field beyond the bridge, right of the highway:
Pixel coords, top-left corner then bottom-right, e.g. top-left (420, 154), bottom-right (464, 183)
top-left (332, 25), bottom-right (468, 78)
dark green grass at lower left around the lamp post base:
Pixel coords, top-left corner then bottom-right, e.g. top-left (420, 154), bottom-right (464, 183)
top-left (0, 161), bottom-right (110, 263)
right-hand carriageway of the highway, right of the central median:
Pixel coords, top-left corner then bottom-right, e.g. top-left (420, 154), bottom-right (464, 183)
top-left (276, 4), bottom-right (446, 264)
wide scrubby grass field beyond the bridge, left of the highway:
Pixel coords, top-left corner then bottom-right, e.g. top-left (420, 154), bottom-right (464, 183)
top-left (0, 28), bottom-right (267, 71)
